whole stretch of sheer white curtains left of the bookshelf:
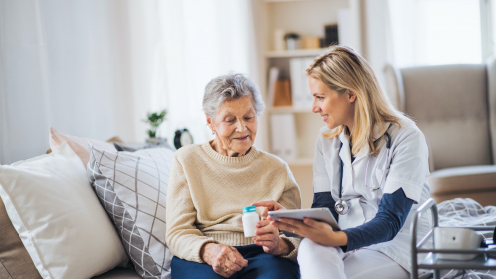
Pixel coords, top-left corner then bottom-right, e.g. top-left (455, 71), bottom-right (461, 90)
top-left (0, 0), bottom-right (259, 164)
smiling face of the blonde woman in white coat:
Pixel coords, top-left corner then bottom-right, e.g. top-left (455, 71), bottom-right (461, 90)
top-left (308, 76), bottom-right (356, 131)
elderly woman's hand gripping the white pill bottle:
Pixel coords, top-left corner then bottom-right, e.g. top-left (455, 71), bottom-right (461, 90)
top-left (253, 220), bottom-right (290, 256)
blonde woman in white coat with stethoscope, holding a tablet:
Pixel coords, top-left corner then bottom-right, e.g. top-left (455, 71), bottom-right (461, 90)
top-left (257, 46), bottom-right (429, 279)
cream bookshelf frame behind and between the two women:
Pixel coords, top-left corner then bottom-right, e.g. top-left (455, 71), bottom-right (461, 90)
top-left (258, 0), bottom-right (350, 208)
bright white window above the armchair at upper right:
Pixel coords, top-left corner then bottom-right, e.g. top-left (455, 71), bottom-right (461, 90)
top-left (389, 0), bottom-right (496, 67)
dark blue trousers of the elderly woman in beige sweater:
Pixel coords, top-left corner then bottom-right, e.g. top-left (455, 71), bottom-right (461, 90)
top-left (171, 244), bottom-right (300, 279)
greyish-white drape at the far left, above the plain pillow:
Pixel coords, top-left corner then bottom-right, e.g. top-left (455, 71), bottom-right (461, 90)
top-left (0, 1), bottom-right (51, 163)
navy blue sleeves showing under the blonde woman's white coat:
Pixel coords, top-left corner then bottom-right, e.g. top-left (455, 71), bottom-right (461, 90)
top-left (312, 188), bottom-right (413, 252)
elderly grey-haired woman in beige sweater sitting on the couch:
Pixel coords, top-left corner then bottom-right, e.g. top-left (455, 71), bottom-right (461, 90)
top-left (166, 74), bottom-right (301, 279)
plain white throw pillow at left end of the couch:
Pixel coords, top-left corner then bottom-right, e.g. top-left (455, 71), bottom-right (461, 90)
top-left (0, 143), bottom-right (128, 279)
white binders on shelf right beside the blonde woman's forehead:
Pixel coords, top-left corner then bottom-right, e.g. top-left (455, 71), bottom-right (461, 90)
top-left (289, 57), bottom-right (314, 111)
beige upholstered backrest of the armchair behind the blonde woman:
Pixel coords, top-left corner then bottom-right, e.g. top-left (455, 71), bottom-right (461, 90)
top-left (401, 64), bottom-right (493, 169)
